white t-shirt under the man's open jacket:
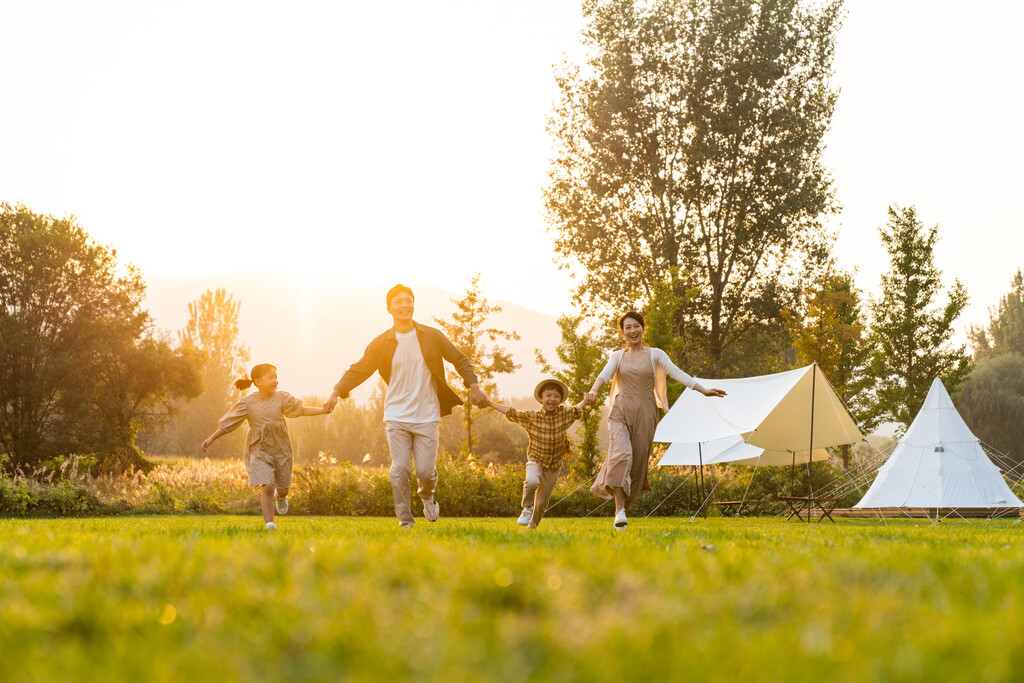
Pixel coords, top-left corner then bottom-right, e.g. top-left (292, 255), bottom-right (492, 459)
top-left (384, 330), bottom-right (441, 423)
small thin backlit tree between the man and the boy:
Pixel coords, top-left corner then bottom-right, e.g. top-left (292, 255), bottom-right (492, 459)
top-left (434, 273), bottom-right (519, 459)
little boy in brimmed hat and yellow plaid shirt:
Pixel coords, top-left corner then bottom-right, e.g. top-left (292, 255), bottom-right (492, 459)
top-left (487, 378), bottom-right (587, 528)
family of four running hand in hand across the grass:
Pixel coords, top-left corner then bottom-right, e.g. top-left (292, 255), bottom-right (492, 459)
top-left (203, 285), bottom-right (725, 529)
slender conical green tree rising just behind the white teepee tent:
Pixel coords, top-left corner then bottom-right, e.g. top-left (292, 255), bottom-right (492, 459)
top-left (869, 206), bottom-right (971, 425)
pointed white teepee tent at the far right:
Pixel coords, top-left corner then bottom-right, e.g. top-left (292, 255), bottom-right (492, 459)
top-left (853, 379), bottom-right (1024, 508)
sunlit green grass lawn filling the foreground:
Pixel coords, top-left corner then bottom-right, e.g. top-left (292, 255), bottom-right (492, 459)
top-left (0, 516), bottom-right (1024, 681)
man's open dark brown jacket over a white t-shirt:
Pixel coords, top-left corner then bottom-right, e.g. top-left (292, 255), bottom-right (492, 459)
top-left (334, 323), bottom-right (477, 416)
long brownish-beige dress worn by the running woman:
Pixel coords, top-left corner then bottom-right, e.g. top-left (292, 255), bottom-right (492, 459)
top-left (590, 349), bottom-right (657, 505)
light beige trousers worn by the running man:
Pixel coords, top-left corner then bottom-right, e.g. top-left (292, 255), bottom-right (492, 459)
top-left (384, 421), bottom-right (440, 522)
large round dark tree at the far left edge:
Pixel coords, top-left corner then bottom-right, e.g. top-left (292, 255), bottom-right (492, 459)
top-left (0, 204), bottom-right (201, 466)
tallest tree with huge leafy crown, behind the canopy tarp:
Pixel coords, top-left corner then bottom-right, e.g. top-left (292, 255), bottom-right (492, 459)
top-left (545, 0), bottom-right (841, 376)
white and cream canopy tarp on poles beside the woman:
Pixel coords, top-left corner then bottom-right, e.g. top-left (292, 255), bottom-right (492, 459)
top-left (654, 365), bottom-right (864, 465)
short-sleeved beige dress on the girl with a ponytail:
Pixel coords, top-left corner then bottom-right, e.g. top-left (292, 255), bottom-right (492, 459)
top-left (220, 391), bottom-right (302, 488)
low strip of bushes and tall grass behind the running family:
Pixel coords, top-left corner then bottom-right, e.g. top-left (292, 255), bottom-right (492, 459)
top-left (0, 454), bottom-right (859, 517)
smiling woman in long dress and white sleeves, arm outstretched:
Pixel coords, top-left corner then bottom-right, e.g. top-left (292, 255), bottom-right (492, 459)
top-left (586, 310), bottom-right (725, 529)
